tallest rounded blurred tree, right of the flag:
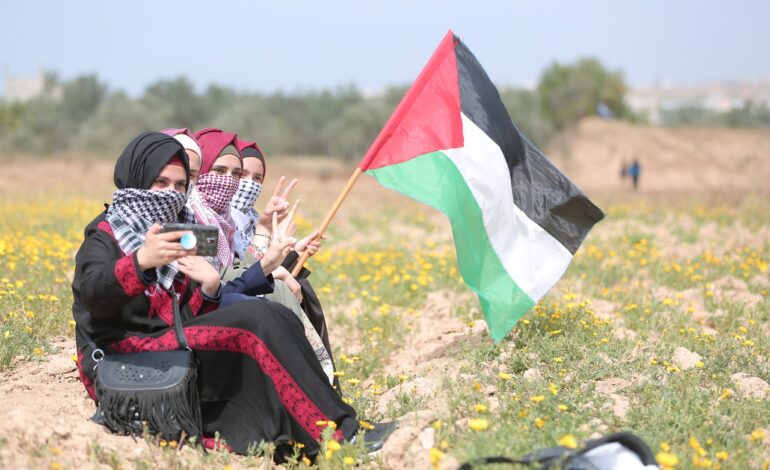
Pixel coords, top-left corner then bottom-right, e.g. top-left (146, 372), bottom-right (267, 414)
top-left (537, 58), bottom-right (630, 130)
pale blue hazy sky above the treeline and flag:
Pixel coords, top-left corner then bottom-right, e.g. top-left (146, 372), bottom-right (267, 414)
top-left (0, 0), bottom-right (770, 95)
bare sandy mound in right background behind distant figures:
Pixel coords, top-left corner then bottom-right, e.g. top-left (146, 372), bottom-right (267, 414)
top-left (548, 118), bottom-right (770, 193)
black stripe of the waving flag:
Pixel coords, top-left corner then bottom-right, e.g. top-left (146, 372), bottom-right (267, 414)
top-left (455, 38), bottom-right (604, 254)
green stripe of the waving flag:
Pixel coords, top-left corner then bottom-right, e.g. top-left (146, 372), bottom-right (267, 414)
top-left (367, 152), bottom-right (535, 341)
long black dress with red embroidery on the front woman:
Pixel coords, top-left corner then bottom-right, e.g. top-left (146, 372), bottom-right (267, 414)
top-left (72, 215), bottom-right (358, 454)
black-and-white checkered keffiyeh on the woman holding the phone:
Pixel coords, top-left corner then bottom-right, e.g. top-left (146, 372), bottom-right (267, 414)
top-left (107, 188), bottom-right (185, 288)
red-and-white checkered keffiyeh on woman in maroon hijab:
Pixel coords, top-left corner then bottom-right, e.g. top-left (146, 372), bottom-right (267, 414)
top-left (187, 173), bottom-right (238, 269)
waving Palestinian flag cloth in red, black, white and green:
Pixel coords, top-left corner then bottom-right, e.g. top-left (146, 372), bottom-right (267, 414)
top-left (360, 31), bottom-right (604, 341)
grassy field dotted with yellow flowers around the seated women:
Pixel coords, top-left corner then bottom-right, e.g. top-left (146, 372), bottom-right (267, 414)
top-left (0, 160), bottom-right (770, 469)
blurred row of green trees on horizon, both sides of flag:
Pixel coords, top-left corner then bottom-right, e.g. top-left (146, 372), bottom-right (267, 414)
top-left (0, 59), bottom-right (632, 160)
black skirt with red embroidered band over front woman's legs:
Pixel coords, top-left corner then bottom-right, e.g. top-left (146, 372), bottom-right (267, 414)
top-left (81, 300), bottom-right (358, 455)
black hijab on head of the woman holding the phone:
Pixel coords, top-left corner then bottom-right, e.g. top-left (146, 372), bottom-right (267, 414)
top-left (114, 132), bottom-right (190, 189)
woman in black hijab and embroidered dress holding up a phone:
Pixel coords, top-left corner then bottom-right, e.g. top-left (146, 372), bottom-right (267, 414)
top-left (72, 132), bottom-right (372, 455)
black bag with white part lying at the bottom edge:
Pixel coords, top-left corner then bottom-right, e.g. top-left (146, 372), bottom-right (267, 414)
top-left (459, 432), bottom-right (658, 470)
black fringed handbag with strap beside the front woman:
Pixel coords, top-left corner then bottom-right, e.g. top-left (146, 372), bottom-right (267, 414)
top-left (80, 284), bottom-right (203, 441)
